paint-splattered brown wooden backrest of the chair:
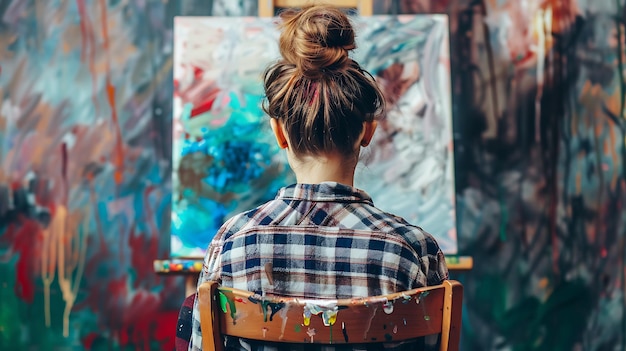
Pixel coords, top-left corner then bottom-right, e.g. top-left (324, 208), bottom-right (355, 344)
top-left (198, 280), bottom-right (463, 351)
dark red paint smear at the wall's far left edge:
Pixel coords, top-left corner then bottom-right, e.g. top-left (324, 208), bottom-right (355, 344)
top-left (2, 215), bottom-right (43, 303)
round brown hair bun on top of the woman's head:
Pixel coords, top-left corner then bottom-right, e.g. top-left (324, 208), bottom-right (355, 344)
top-left (279, 6), bottom-right (356, 79)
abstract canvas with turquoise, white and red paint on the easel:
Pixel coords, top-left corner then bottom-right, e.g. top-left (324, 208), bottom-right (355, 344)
top-left (171, 15), bottom-right (457, 258)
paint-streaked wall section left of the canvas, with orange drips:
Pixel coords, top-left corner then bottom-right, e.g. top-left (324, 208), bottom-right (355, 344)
top-left (0, 0), bottom-right (183, 350)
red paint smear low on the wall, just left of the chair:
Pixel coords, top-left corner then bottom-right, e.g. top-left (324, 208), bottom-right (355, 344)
top-left (75, 224), bottom-right (182, 350)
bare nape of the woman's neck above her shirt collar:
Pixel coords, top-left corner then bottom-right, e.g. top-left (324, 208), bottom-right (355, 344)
top-left (289, 155), bottom-right (356, 186)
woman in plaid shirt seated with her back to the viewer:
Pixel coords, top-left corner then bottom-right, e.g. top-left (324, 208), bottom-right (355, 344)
top-left (190, 6), bottom-right (448, 350)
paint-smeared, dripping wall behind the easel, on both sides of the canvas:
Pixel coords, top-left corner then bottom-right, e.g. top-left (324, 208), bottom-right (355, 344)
top-left (0, 0), bottom-right (626, 350)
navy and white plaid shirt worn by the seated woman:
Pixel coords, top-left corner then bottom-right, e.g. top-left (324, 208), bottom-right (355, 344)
top-left (189, 182), bottom-right (448, 351)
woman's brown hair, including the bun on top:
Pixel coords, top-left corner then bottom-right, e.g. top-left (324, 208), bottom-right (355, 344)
top-left (263, 5), bottom-right (384, 156)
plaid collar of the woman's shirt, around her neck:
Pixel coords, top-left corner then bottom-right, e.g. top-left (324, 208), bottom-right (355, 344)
top-left (276, 182), bottom-right (374, 205)
